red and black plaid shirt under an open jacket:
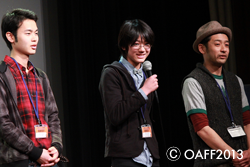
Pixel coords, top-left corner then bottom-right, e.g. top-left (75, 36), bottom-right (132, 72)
top-left (4, 56), bottom-right (52, 149)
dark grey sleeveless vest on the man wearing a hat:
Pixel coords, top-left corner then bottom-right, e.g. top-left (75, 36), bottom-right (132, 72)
top-left (186, 64), bottom-right (247, 167)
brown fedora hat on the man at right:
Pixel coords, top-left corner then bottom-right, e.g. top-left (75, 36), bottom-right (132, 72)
top-left (193, 21), bottom-right (232, 53)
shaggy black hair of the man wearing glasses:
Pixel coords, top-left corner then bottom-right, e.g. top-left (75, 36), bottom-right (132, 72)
top-left (118, 19), bottom-right (154, 58)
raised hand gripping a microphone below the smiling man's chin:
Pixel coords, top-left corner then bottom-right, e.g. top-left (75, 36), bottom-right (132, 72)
top-left (141, 61), bottom-right (159, 95)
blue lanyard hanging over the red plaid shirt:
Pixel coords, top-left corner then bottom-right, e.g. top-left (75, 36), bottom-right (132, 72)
top-left (11, 57), bottom-right (42, 125)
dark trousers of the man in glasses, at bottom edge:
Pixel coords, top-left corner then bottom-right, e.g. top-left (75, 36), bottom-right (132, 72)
top-left (111, 158), bottom-right (160, 167)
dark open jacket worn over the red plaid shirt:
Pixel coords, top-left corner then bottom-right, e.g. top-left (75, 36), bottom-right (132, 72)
top-left (0, 61), bottom-right (62, 164)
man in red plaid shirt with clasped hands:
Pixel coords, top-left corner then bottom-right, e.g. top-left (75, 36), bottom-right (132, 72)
top-left (0, 8), bottom-right (63, 167)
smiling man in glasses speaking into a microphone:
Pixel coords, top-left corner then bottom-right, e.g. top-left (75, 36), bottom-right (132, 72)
top-left (99, 19), bottom-right (160, 167)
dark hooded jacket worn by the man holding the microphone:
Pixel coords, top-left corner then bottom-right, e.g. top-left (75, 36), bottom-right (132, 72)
top-left (99, 62), bottom-right (160, 159)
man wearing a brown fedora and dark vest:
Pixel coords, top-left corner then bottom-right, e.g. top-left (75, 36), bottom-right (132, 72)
top-left (182, 21), bottom-right (250, 167)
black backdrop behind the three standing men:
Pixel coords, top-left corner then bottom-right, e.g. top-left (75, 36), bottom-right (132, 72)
top-left (42, 0), bottom-right (250, 167)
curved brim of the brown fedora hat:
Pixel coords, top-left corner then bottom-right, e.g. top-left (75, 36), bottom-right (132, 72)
top-left (193, 27), bottom-right (232, 54)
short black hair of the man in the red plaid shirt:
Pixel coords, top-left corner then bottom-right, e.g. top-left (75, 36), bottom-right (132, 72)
top-left (1, 8), bottom-right (38, 50)
